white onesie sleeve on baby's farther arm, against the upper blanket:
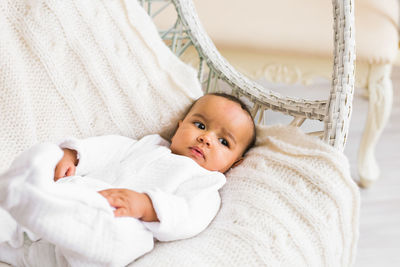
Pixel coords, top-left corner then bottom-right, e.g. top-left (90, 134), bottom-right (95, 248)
top-left (59, 135), bottom-right (137, 176)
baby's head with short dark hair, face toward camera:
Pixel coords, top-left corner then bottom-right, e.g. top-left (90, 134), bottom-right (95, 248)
top-left (171, 94), bottom-right (255, 173)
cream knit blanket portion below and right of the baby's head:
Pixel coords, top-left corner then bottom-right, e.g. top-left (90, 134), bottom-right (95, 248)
top-left (134, 126), bottom-right (360, 267)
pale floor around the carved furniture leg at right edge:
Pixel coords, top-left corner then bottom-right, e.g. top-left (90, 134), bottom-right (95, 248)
top-left (345, 67), bottom-right (400, 267)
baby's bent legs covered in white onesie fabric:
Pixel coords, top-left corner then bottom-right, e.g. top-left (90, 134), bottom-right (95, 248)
top-left (0, 144), bottom-right (153, 267)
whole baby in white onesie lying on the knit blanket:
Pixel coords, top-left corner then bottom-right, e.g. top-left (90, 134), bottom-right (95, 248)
top-left (0, 94), bottom-right (255, 266)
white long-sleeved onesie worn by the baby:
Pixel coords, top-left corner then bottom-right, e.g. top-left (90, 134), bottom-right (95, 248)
top-left (0, 135), bottom-right (226, 266)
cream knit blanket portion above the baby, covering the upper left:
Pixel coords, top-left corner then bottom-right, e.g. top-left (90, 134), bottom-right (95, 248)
top-left (0, 0), bottom-right (202, 172)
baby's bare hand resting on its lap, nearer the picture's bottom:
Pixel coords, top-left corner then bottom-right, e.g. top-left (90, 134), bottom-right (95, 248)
top-left (99, 188), bottom-right (158, 222)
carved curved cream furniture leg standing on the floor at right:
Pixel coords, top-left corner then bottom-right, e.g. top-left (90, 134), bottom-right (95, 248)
top-left (358, 64), bottom-right (393, 187)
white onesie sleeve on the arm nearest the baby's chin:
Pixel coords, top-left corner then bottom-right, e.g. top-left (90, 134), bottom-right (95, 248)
top-left (144, 172), bottom-right (226, 241)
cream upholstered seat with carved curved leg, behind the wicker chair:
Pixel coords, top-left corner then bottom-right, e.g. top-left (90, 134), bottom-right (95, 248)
top-left (188, 0), bottom-right (399, 187)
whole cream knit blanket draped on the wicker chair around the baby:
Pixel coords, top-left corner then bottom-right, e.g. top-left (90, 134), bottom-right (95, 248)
top-left (0, 0), bottom-right (359, 267)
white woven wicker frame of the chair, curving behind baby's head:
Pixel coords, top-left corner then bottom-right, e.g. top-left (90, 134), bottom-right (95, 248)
top-left (140, 0), bottom-right (355, 151)
